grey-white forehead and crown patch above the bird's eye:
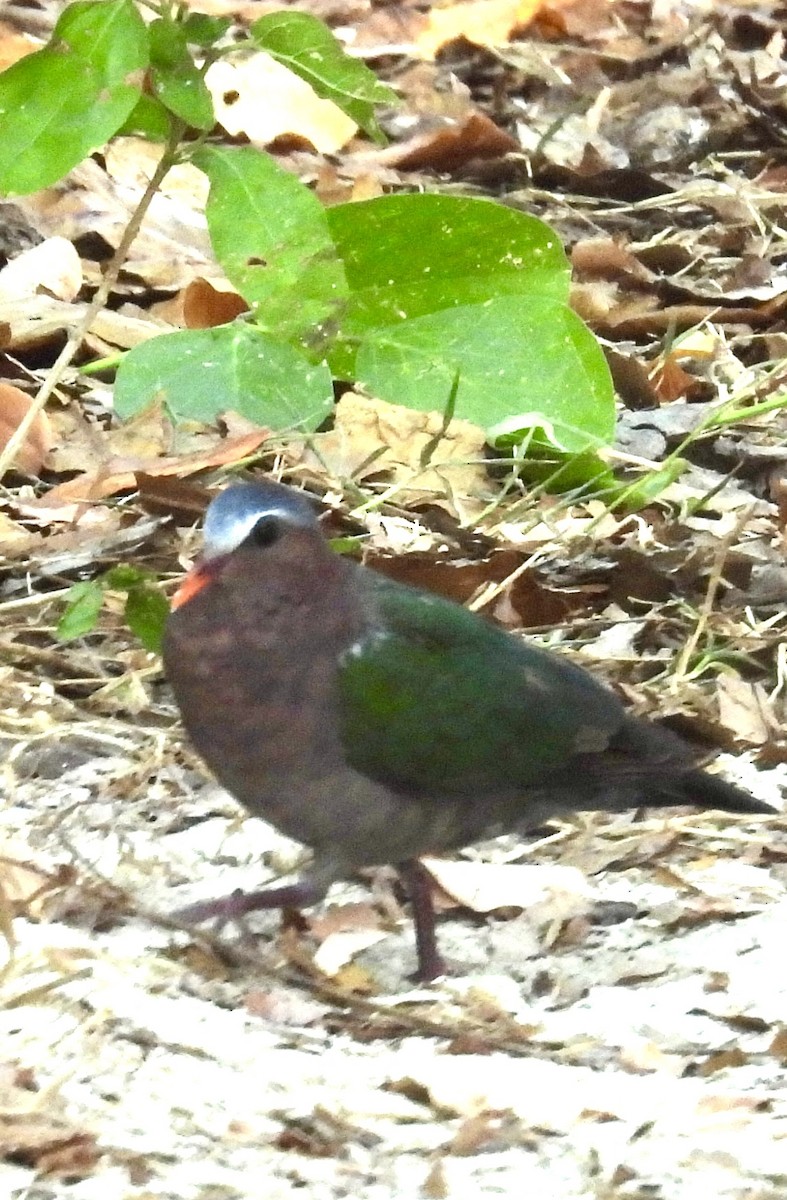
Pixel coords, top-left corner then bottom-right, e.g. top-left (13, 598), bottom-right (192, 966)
top-left (204, 484), bottom-right (317, 558)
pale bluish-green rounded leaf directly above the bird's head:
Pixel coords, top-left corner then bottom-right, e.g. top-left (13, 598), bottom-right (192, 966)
top-left (115, 324), bottom-right (334, 430)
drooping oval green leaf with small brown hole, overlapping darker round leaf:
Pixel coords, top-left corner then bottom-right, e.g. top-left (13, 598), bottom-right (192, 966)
top-left (194, 146), bottom-right (348, 340)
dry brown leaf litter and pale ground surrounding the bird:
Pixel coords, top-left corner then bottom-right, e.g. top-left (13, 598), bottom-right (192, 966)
top-left (0, 0), bottom-right (787, 1200)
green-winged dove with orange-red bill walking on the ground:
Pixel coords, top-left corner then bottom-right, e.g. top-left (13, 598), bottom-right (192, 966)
top-left (163, 476), bottom-right (775, 980)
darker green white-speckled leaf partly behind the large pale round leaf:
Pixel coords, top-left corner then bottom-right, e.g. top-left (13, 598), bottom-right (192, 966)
top-left (328, 196), bottom-right (571, 374)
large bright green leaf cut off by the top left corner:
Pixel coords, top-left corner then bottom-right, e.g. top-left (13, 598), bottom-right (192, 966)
top-left (0, 0), bottom-right (148, 194)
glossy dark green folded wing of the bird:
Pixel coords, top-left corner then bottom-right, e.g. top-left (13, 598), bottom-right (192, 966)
top-left (340, 577), bottom-right (624, 797)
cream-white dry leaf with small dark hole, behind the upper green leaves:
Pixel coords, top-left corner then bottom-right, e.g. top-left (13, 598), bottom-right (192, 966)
top-left (205, 50), bottom-right (358, 154)
